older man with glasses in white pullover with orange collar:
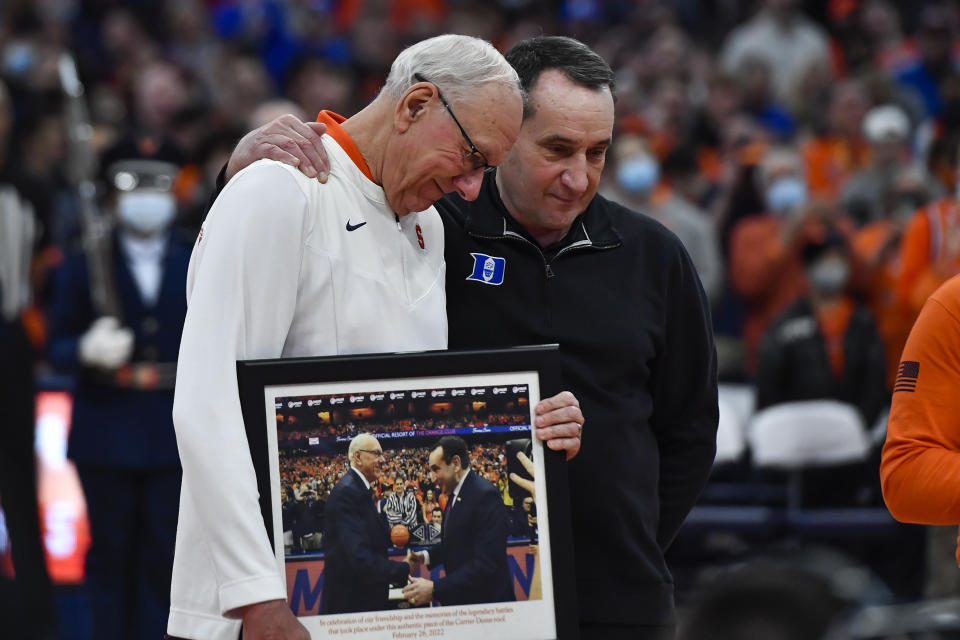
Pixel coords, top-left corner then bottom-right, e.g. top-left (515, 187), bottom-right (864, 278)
top-left (168, 35), bottom-right (522, 640)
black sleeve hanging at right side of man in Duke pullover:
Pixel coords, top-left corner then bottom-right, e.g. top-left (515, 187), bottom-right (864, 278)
top-left (651, 241), bottom-right (719, 549)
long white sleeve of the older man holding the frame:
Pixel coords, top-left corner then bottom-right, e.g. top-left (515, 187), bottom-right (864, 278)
top-left (173, 161), bottom-right (308, 614)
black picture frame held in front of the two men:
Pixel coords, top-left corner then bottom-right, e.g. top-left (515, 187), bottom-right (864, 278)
top-left (237, 344), bottom-right (579, 640)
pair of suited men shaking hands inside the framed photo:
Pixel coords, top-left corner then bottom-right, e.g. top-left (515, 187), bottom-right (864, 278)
top-left (322, 434), bottom-right (515, 614)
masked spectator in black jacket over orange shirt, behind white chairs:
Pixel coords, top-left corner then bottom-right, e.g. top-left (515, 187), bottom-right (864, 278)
top-left (757, 231), bottom-right (886, 424)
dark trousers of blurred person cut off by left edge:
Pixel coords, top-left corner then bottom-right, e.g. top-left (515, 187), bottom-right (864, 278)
top-left (0, 319), bottom-right (56, 638)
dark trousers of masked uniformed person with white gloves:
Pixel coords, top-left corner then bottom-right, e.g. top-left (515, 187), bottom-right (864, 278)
top-left (77, 464), bottom-right (180, 640)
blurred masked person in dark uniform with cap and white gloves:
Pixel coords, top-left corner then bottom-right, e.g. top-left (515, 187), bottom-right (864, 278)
top-left (49, 159), bottom-right (190, 638)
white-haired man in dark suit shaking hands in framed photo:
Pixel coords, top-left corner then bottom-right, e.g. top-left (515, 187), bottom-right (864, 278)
top-left (322, 433), bottom-right (410, 614)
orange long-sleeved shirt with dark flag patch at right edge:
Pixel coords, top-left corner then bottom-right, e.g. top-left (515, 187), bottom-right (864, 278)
top-left (880, 276), bottom-right (960, 564)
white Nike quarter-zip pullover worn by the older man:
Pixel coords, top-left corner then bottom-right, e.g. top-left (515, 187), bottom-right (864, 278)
top-left (167, 135), bottom-right (447, 640)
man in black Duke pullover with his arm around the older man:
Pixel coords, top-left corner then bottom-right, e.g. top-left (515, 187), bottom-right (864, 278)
top-left (221, 37), bottom-right (718, 640)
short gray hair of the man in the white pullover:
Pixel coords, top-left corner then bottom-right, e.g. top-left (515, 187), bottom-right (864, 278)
top-left (384, 33), bottom-right (523, 102)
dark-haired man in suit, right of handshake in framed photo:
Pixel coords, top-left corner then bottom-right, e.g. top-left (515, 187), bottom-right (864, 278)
top-left (403, 436), bottom-right (515, 605)
